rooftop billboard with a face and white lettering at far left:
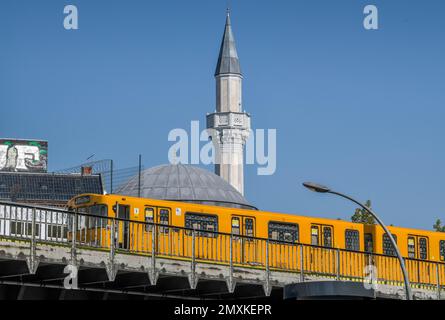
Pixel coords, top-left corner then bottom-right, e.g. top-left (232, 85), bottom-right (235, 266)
top-left (0, 139), bottom-right (48, 172)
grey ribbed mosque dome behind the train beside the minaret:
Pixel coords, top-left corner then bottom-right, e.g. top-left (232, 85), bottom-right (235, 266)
top-left (116, 164), bottom-right (256, 209)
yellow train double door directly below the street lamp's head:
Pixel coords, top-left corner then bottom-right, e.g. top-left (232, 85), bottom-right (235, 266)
top-left (309, 224), bottom-right (334, 273)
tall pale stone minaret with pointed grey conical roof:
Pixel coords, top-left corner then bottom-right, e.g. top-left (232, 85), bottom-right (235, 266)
top-left (207, 11), bottom-right (250, 194)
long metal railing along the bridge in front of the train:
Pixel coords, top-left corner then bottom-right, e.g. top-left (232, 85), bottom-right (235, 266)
top-left (0, 202), bottom-right (445, 293)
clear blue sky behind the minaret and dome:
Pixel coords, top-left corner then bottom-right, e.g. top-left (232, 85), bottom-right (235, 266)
top-left (0, 0), bottom-right (445, 229)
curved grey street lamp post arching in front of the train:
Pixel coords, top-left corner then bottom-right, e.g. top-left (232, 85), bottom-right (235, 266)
top-left (303, 182), bottom-right (413, 300)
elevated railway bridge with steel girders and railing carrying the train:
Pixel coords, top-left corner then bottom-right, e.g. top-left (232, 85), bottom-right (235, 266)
top-left (0, 202), bottom-right (445, 299)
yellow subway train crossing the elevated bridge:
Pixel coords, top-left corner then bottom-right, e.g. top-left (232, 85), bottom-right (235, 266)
top-left (68, 194), bottom-right (445, 286)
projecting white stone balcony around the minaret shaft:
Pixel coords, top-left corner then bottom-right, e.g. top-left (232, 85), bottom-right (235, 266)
top-left (207, 112), bottom-right (250, 130)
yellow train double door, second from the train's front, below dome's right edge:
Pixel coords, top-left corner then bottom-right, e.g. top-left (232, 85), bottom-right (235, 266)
top-left (232, 215), bottom-right (257, 264)
